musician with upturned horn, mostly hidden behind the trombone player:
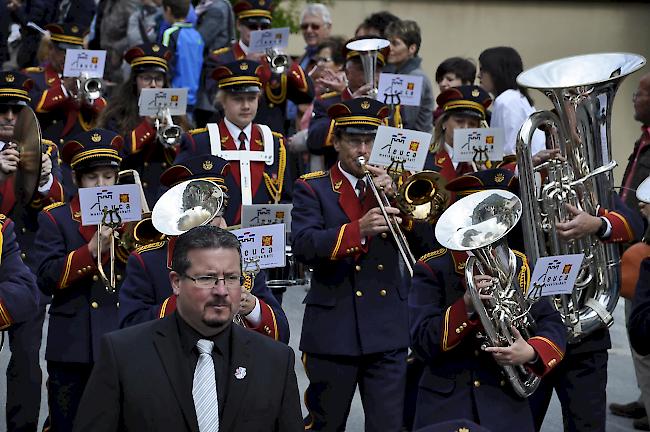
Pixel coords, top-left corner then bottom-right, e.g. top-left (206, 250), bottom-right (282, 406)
top-left (307, 37), bottom-right (390, 168)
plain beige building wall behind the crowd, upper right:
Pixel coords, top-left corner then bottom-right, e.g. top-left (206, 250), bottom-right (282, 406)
top-left (289, 0), bottom-right (650, 182)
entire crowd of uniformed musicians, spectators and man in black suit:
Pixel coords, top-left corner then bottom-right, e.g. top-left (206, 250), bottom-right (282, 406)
top-left (0, 0), bottom-right (650, 432)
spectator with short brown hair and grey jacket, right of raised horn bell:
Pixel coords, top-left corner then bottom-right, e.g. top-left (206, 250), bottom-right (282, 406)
top-left (384, 20), bottom-right (433, 133)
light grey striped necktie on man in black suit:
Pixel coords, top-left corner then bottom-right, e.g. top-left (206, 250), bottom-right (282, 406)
top-left (192, 339), bottom-right (219, 432)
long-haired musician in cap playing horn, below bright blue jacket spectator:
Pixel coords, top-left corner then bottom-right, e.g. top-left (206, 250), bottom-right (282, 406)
top-left (98, 43), bottom-right (185, 206)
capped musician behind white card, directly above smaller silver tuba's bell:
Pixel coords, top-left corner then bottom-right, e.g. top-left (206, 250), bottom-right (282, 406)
top-left (424, 85), bottom-right (492, 185)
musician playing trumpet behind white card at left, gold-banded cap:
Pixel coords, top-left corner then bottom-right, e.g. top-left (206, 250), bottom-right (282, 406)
top-left (34, 129), bottom-right (123, 431)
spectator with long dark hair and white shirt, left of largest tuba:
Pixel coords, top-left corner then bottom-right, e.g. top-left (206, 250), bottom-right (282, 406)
top-left (478, 47), bottom-right (546, 155)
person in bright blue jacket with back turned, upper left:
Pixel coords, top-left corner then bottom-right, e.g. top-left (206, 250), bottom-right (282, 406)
top-left (162, 0), bottom-right (205, 114)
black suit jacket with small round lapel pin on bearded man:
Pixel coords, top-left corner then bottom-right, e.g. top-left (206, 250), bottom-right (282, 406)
top-left (74, 315), bottom-right (304, 432)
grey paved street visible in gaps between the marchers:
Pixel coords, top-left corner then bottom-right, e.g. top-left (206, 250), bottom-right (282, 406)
top-left (0, 287), bottom-right (638, 432)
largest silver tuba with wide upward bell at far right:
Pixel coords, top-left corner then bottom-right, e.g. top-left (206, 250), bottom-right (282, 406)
top-left (517, 53), bottom-right (645, 342)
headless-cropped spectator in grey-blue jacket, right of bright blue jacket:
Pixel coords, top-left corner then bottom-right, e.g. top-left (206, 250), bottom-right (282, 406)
top-left (195, 0), bottom-right (236, 52)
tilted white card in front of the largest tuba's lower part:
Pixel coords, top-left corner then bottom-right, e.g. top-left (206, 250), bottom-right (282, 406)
top-left (528, 254), bottom-right (585, 298)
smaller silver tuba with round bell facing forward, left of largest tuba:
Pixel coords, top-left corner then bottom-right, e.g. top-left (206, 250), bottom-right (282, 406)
top-left (436, 190), bottom-right (540, 397)
